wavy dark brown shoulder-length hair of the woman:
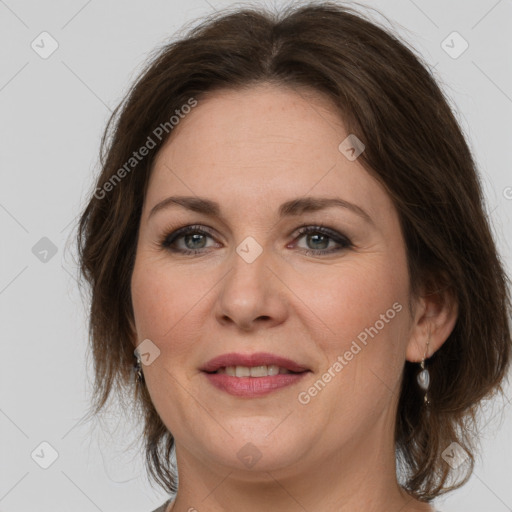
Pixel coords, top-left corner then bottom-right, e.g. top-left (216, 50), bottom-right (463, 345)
top-left (77, 2), bottom-right (511, 501)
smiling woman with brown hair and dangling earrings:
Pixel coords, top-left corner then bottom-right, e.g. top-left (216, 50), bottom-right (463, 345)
top-left (78, 3), bottom-right (511, 512)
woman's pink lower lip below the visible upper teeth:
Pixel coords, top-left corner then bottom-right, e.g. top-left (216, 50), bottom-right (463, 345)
top-left (204, 372), bottom-right (309, 397)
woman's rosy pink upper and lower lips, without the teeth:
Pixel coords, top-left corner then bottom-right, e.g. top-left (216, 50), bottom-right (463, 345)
top-left (201, 352), bottom-right (310, 398)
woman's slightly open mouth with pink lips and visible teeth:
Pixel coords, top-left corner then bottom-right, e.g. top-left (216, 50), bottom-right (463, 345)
top-left (201, 353), bottom-right (311, 398)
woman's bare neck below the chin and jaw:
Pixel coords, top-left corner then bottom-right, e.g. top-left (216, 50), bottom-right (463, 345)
top-left (172, 404), bottom-right (433, 512)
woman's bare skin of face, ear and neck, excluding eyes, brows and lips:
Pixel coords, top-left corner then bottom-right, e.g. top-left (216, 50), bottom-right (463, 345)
top-left (131, 84), bottom-right (457, 512)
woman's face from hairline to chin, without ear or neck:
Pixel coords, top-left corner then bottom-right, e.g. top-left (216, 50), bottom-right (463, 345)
top-left (131, 85), bottom-right (418, 474)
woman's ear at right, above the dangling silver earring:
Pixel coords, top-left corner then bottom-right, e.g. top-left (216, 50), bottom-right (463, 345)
top-left (406, 287), bottom-right (458, 363)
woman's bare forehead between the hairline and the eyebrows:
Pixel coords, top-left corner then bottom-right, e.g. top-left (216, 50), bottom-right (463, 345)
top-left (146, 85), bottom-right (390, 224)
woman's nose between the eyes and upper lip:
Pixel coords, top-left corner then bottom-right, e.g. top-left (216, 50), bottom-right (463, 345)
top-left (216, 244), bottom-right (288, 331)
